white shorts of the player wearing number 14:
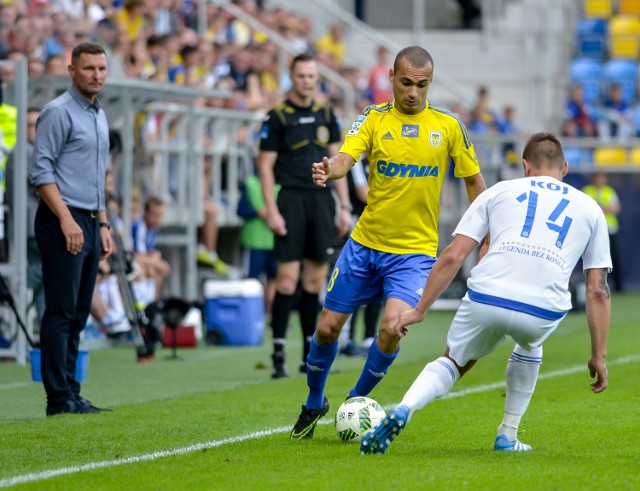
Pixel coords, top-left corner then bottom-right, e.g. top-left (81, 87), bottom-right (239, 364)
top-left (447, 295), bottom-right (564, 367)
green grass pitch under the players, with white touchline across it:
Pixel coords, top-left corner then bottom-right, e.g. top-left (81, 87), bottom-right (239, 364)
top-left (0, 294), bottom-right (640, 490)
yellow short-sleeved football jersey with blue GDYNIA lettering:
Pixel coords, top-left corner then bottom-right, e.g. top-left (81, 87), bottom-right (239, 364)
top-left (340, 102), bottom-right (480, 256)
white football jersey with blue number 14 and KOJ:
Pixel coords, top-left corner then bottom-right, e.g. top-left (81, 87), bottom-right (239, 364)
top-left (453, 176), bottom-right (611, 318)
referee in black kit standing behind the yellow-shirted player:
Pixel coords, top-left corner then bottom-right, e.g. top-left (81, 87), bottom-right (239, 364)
top-left (258, 54), bottom-right (351, 378)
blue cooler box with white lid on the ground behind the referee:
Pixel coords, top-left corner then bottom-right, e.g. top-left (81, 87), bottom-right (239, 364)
top-left (204, 279), bottom-right (264, 345)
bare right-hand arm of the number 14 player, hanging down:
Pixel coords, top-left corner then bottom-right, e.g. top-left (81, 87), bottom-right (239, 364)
top-left (585, 269), bottom-right (611, 393)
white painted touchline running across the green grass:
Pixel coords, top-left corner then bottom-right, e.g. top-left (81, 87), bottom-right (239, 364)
top-left (0, 355), bottom-right (640, 488)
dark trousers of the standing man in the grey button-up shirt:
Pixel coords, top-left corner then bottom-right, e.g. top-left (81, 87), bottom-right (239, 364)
top-left (35, 202), bottom-right (101, 405)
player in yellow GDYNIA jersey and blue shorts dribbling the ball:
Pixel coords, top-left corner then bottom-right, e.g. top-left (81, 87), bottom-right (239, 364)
top-left (290, 46), bottom-right (486, 440)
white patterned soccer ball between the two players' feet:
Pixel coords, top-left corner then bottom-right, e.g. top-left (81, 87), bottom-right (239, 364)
top-left (336, 397), bottom-right (386, 442)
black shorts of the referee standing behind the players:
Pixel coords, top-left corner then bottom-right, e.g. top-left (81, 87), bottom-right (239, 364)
top-left (274, 189), bottom-right (337, 263)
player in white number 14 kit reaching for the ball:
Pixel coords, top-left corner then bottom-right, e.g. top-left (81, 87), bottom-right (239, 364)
top-left (360, 133), bottom-right (611, 453)
